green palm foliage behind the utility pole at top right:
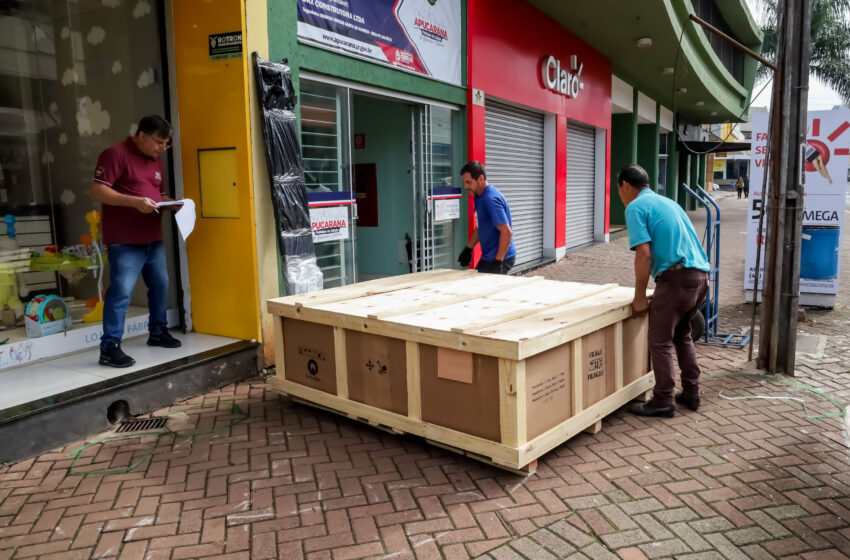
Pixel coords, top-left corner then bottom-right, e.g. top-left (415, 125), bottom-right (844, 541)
top-left (759, 0), bottom-right (850, 105)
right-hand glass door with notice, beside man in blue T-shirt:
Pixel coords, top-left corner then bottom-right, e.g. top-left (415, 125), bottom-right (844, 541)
top-left (411, 105), bottom-right (461, 272)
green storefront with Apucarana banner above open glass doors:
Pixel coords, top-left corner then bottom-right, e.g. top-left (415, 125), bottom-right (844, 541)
top-left (256, 0), bottom-right (466, 306)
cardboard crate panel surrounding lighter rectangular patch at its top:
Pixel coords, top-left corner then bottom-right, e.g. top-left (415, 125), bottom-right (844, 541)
top-left (419, 344), bottom-right (501, 441)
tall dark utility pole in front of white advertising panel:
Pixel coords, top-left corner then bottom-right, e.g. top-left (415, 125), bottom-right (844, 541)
top-left (757, 0), bottom-right (812, 375)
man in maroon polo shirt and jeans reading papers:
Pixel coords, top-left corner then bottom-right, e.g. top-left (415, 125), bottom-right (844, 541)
top-left (91, 116), bottom-right (180, 367)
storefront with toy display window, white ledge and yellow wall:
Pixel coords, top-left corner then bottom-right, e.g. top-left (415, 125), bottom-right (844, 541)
top-left (0, 0), bottom-right (260, 461)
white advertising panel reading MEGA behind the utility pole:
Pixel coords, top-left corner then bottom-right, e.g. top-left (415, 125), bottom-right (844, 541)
top-left (744, 109), bottom-right (850, 295)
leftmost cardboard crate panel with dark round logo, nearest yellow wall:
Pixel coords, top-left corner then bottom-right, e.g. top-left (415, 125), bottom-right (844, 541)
top-left (283, 319), bottom-right (336, 395)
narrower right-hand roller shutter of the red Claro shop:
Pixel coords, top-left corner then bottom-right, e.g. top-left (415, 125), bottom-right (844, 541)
top-left (566, 121), bottom-right (596, 249)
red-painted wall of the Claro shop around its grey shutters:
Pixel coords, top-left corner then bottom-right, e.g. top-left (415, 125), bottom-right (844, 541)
top-left (467, 0), bottom-right (612, 262)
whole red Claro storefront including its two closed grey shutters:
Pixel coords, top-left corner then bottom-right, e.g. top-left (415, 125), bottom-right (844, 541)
top-left (468, 0), bottom-right (611, 269)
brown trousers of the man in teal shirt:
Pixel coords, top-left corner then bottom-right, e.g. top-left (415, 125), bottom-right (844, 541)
top-left (649, 268), bottom-right (708, 406)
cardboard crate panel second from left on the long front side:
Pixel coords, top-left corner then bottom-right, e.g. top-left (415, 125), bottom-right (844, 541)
top-left (345, 331), bottom-right (407, 415)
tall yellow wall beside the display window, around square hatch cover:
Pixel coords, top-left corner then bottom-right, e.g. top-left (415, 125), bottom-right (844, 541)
top-left (173, 0), bottom-right (258, 340)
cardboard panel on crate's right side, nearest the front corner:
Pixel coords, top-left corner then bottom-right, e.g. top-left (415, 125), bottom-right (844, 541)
top-left (525, 342), bottom-right (573, 439)
